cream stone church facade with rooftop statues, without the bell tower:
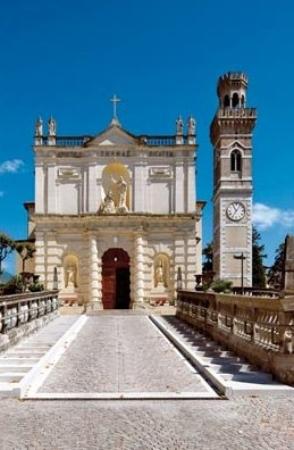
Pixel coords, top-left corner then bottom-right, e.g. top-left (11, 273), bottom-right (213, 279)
top-left (27, 109), bottom-right (204, 309)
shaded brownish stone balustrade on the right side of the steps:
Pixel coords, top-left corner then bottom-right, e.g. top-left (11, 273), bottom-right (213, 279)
top-left (177, 290), bottom-right (294, 384)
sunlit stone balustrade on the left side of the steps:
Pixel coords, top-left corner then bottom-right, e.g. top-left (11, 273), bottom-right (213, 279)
top-left (0, 291), bottom-right (59, 351)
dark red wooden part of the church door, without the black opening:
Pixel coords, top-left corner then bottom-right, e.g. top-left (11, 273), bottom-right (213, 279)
top-left (102, 248), bottom-right (130, 309)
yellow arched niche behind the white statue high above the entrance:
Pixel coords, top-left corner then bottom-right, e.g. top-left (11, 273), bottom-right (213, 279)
top-left (101, 162), bottom-right (131, 212)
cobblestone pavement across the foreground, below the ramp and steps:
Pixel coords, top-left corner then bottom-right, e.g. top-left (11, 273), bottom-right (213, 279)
top-left (0, 398), bottom-right (294, 450)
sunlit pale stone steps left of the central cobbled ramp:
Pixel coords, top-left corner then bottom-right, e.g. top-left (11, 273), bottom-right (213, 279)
top-left (0, 316), bottom-right (76, 396)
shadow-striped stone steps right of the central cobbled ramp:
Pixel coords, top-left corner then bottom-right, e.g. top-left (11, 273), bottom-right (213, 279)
top-left (152, 316), bottom-right (294, 397)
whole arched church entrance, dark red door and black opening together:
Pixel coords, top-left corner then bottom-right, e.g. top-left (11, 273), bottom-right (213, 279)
top-left (102, 248), bottom-right (130, 309)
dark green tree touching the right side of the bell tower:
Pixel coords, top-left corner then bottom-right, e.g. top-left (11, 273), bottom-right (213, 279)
top-left (252, 227), bottom-right (266, 289)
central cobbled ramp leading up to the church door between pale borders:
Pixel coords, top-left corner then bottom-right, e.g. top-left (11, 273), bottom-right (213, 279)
top-left (40, 315), bottom-right (207, 393)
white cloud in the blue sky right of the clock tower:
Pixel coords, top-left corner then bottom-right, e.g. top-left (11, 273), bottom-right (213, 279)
top-left (253, 203), bottom-right (294, 230)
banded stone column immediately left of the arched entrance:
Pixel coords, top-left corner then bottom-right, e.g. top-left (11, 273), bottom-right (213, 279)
top-left (89, 235), bottom-right (102, 310)
